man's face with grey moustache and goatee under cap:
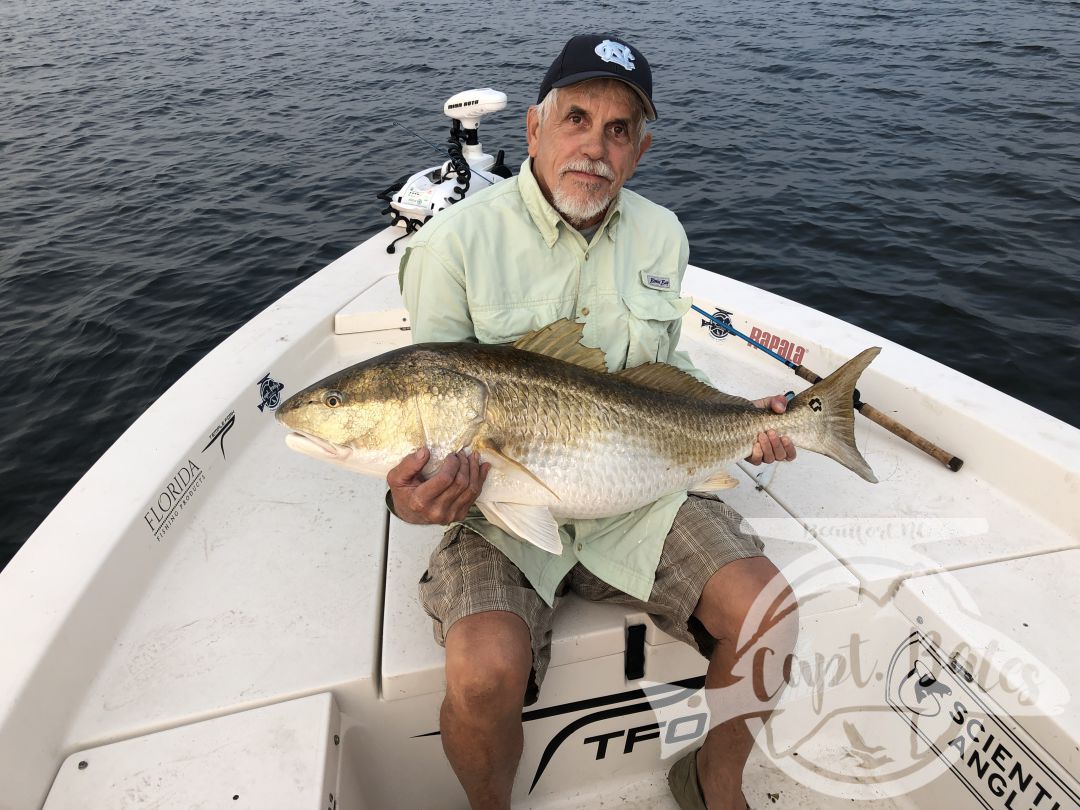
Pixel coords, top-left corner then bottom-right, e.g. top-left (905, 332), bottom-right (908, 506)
top-left (527, 82), bottom-right (652, 228)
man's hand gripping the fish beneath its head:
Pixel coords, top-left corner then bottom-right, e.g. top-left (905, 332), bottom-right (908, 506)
top-left (387, 447), bottom-right (491, 526)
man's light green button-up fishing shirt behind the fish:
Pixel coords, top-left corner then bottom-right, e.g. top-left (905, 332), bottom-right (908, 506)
top-left (399, 160), bottom-right (707, 605)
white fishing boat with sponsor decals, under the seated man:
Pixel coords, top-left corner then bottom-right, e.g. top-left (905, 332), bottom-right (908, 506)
top-left (0, 91), bottom-right (1080, 810)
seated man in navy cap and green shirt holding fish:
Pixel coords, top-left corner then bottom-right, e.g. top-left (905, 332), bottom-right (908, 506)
top-left (387, 36), bottom-right (795, 810)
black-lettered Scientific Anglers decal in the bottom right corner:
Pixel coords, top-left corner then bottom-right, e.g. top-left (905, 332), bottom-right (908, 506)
top-left (886, 630), bottom-right (1080, 810)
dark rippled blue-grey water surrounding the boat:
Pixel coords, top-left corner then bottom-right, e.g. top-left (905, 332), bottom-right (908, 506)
top-left (0, 0), bottom-right (1080, 563)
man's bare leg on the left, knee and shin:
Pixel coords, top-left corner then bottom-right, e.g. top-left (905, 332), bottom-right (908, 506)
top-left (440, 611), bottom-right (532, 810)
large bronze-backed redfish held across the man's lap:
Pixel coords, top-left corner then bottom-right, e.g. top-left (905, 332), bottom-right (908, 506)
top-left (278, 321), bottom-right (880, 554)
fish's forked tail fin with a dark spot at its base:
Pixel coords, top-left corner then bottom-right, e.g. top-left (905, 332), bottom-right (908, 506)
top-left (788, 348), bottom-right (881, 484)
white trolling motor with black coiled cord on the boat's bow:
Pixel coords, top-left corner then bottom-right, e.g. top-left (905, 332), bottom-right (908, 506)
top-left (379, 87), bottom-right (511, 253)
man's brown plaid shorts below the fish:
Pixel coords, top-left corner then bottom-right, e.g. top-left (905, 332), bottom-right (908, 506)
top-left (420, 495), bottom-right (765, 705)
